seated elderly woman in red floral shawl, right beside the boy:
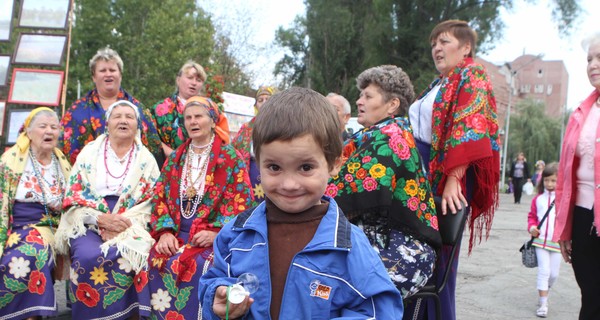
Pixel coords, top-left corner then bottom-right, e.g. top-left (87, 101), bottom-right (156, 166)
top-left (149, 96), bottom-right (251, 319)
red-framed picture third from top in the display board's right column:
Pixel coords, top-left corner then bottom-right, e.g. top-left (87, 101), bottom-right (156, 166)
top-left (8, 68), bottom-right (65, 106)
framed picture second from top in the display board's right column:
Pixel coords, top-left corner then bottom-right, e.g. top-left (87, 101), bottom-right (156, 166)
top-left (13, 33), bottom-right (67, 67)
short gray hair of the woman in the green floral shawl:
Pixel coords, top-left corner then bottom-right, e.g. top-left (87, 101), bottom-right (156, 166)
top-left (356, 65), bottom-right (415, 116)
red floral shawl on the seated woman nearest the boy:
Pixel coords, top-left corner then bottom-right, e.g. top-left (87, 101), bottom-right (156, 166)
top-left (151, 136), bottom-right (252, 240)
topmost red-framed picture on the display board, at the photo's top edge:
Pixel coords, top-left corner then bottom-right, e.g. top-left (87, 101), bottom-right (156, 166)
top-left (19, 0), bottom-right (71, 29)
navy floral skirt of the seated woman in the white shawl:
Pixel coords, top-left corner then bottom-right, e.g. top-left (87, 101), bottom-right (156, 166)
top-left (68, 230), bottom-right (150, 320)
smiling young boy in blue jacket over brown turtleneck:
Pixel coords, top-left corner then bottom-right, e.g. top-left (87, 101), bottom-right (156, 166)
top-left (199, 88), bottom-right (403, 319)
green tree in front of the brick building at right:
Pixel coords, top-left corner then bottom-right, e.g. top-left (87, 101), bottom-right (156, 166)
top-left (507, 99), bottom-right (561, 169)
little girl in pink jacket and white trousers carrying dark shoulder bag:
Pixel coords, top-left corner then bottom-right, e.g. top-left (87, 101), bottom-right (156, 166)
top-left (527, 162), bottom-right (562, 318)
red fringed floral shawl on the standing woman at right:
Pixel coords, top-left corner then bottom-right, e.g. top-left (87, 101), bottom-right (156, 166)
top-left (419, 58), bottom-right (500, 250)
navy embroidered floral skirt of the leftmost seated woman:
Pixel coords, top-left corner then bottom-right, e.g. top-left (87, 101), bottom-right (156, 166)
top-left (0, 203), bottom-right (57, 319)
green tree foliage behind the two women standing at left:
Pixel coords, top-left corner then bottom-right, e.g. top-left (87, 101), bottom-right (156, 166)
top-left (67, 0), bottom-right (214, 106)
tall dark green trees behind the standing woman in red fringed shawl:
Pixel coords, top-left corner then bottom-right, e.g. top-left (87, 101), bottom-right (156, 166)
top-left (275, 0), bottom-right (580, 109)
